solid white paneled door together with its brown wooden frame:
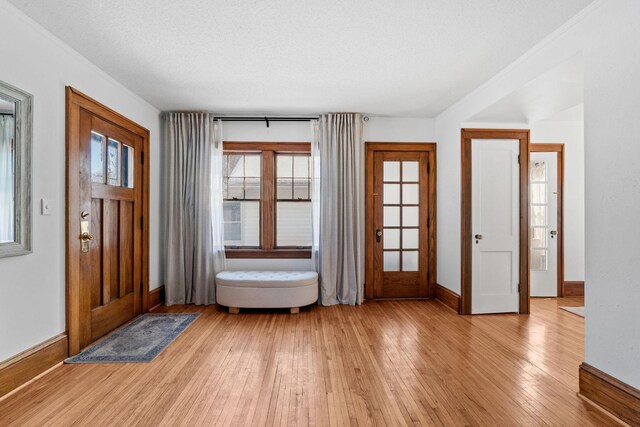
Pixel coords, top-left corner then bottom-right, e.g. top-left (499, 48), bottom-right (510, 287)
top-left (460, 129), bottom-right (529, 314)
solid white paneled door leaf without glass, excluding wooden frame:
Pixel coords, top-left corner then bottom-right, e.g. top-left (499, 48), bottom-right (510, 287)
top-left (471, 139), bottom-right (520, 314)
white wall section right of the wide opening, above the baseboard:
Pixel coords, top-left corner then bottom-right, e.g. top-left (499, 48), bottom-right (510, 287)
top-left (584, 0), bottom-right (640, 388)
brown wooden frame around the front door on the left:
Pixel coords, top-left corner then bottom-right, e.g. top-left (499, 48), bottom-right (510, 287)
top-left (65, 86), bottom-right (150, 356)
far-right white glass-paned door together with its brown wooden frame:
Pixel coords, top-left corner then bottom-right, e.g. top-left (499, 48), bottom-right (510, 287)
top-left (529, 144), bottom-right (564, 297)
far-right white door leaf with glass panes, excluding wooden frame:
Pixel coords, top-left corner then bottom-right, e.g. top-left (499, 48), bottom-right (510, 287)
top-left (529, 153), bottom-right (558, 297)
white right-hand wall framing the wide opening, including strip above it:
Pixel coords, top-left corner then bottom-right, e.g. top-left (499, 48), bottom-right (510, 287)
top-left (436, 0), bottom-right (640, 388)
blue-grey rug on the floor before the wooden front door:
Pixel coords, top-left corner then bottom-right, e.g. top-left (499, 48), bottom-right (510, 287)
top-left (64, 313), bottom-right (199, 363)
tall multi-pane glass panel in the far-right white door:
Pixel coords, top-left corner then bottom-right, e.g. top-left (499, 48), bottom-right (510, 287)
top-left (529, 161), bottom-right (549, 271)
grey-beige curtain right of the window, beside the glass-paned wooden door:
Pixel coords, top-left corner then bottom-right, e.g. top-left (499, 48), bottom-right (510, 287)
top-left (314, 113), bottom-right (364, 305)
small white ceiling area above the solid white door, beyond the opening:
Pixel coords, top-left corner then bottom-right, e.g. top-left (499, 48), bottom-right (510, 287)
top-left (469, 56), bottom-right (584, 123)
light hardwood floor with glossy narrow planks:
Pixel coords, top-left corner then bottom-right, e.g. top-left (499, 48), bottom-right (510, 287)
top-left (0, 298), bottom-right (613, 426)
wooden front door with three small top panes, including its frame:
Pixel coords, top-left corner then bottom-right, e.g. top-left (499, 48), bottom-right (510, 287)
top-left (67, 89), bottom-right (148, 354)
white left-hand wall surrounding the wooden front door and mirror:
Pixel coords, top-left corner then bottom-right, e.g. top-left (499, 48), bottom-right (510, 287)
top-left (0, 0), bottom-right (159, 360)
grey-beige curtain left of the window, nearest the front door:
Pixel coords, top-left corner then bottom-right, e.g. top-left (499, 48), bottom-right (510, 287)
top-left (162, 113), bottom-right (225, 305)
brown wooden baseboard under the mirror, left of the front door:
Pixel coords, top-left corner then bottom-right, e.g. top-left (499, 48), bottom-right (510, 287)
top-left (0, 332), bottom-right (69, 397)
